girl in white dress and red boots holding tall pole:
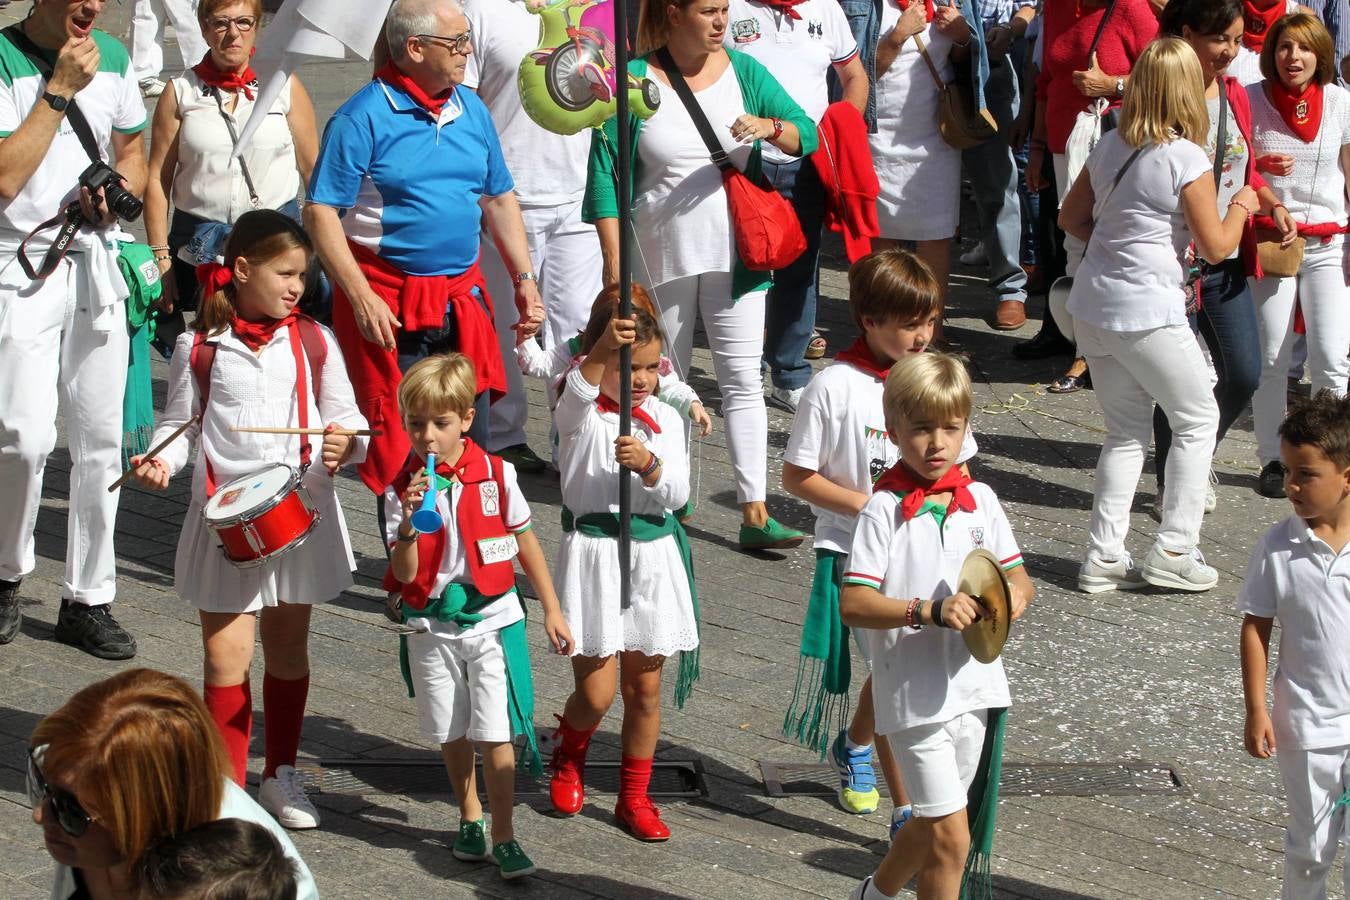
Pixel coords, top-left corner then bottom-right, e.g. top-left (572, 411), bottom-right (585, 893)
top-left (549, 302), bottom-right (698, 841)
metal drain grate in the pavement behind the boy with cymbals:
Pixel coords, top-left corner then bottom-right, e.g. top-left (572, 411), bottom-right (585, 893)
top-left (760, 761), bottom-right (1191, 797)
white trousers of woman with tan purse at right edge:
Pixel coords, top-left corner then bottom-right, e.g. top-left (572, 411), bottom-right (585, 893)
top-left (1251, 237), bottom-right (1350, 466)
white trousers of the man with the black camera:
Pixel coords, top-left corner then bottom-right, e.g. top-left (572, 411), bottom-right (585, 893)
top-left (0, 254), bottom-right (130, 606)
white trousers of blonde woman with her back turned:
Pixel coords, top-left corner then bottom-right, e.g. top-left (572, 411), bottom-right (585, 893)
top-left (1073, 320), bottom-right (1219, 560)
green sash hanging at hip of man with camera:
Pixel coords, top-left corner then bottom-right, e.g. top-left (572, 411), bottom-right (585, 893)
top-left (117, 243), bottom-right (163, 467)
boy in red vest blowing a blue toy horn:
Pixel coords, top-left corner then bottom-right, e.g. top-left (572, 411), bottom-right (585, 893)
top-left (383, 354), bottom-right (572, 880)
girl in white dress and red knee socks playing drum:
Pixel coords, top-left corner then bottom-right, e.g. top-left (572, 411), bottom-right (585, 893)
top-left (131, 209), bottom-right (366, 828)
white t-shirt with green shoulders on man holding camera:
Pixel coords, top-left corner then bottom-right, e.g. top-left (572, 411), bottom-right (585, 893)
top-left (0, 31), bottom-right (146, 240)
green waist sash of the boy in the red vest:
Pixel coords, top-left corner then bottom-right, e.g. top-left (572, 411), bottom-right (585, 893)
top-left (398, 582), bottom-right (544, 779)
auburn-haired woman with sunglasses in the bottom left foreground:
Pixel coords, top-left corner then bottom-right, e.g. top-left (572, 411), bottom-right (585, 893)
top-left (28, 669), bottom-right (319, 900)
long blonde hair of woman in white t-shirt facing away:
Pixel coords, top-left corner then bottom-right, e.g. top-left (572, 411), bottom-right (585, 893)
top-left (1118, 38), bottom-right (1210, 147)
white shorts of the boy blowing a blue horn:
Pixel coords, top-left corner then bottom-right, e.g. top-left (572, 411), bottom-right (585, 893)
top-left (408, 631), bottom-right (510, 743)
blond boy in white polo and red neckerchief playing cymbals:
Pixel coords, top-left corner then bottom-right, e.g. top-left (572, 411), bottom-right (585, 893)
top-left (840, 354), bottom-right (1035, 900)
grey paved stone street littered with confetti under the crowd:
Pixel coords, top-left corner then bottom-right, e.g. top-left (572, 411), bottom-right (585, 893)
top-left (0, 4), bottom-right (1341, 900)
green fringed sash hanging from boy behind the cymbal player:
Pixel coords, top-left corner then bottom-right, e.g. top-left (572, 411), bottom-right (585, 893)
top-left (783, 549), bottom-right (853, 760)
